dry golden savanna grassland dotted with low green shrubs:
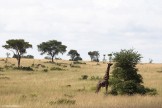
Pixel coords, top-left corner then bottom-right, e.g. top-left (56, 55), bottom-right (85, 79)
top-left (0, 58), bottom-right (162, 108)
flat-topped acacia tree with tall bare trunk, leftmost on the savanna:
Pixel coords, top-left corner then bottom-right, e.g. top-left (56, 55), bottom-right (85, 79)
top-left (2, 39), bottom-right (32, 67)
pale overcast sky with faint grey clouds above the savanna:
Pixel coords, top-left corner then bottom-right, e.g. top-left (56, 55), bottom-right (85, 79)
top-left (0, 0), bottom-right (162, 63)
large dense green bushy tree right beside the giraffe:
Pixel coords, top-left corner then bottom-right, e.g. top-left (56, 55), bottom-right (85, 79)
top-left (110, 49), bottom-right (157, 95)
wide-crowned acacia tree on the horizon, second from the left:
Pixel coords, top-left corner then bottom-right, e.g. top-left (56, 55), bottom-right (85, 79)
top-left (37, 40), bottom-right (67, 62)
